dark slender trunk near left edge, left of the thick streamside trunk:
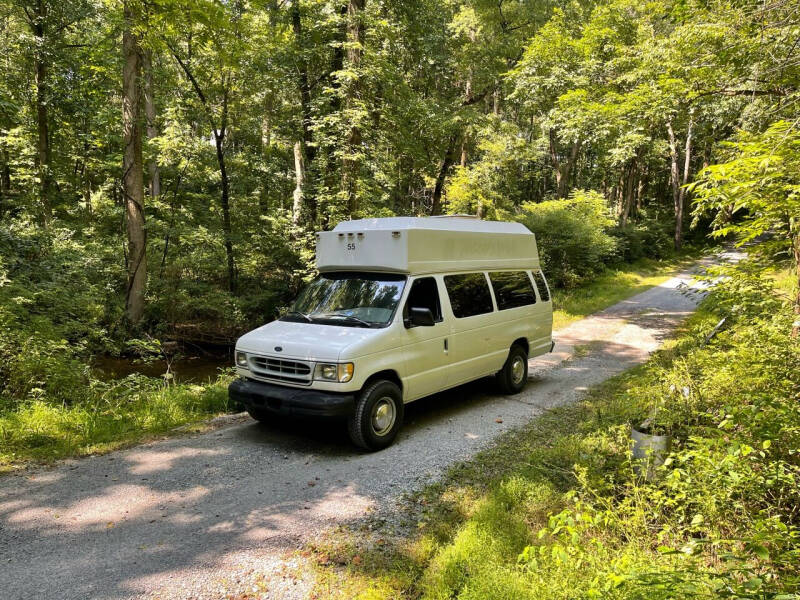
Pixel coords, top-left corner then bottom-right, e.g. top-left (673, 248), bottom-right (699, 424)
top-left (29, 0), bottom-right (53, 224)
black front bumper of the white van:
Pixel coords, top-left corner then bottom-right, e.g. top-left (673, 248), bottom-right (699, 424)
top-left (228, 379), bottom-right (355, 417)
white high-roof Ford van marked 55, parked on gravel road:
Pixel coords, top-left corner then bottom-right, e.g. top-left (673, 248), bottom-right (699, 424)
top-left (229, 217), bottom-right (553, 450)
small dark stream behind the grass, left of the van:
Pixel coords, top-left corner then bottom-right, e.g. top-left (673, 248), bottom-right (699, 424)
top-left (93, 350), bottom-right (233, 383)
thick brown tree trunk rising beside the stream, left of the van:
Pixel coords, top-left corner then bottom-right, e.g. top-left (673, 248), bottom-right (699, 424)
top-left (122, 1), bottom-right (147, 324)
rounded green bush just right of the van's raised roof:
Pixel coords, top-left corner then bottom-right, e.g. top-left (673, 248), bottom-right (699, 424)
top-left (521, 190), bottom-right (617, 288)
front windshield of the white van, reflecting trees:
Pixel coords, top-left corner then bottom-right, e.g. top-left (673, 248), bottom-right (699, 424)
top-left (281, 273), bottom-right (406, 327)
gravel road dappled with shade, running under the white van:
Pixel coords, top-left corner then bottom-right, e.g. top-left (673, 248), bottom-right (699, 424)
top-left (0, 255), bottom-right (736, 600)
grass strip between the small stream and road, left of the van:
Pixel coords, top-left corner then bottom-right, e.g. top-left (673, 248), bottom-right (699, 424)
top-left (0, 374), bottom-right (233, 473)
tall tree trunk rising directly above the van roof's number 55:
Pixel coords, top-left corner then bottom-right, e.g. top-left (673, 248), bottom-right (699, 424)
top-left (342, 0), bottom-right (365, 217)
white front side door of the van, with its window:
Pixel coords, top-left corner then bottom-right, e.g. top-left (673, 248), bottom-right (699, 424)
top-left (403, 277), bottom-right (450, 401)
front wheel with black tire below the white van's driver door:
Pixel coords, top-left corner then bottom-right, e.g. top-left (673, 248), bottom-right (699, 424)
top-left (347, 379), bottom-right (403, 450)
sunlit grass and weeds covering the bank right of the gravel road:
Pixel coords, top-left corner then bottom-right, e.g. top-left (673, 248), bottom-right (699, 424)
top-left (310, 274), bottom-right (800, 600)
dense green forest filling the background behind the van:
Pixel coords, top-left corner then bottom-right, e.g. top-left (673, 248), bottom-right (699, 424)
top-left (0, 0), bottom-right (800, 352)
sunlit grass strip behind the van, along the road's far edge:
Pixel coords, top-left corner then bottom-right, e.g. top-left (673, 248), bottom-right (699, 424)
top-left (553, 246), bottom-right (711, 329)
